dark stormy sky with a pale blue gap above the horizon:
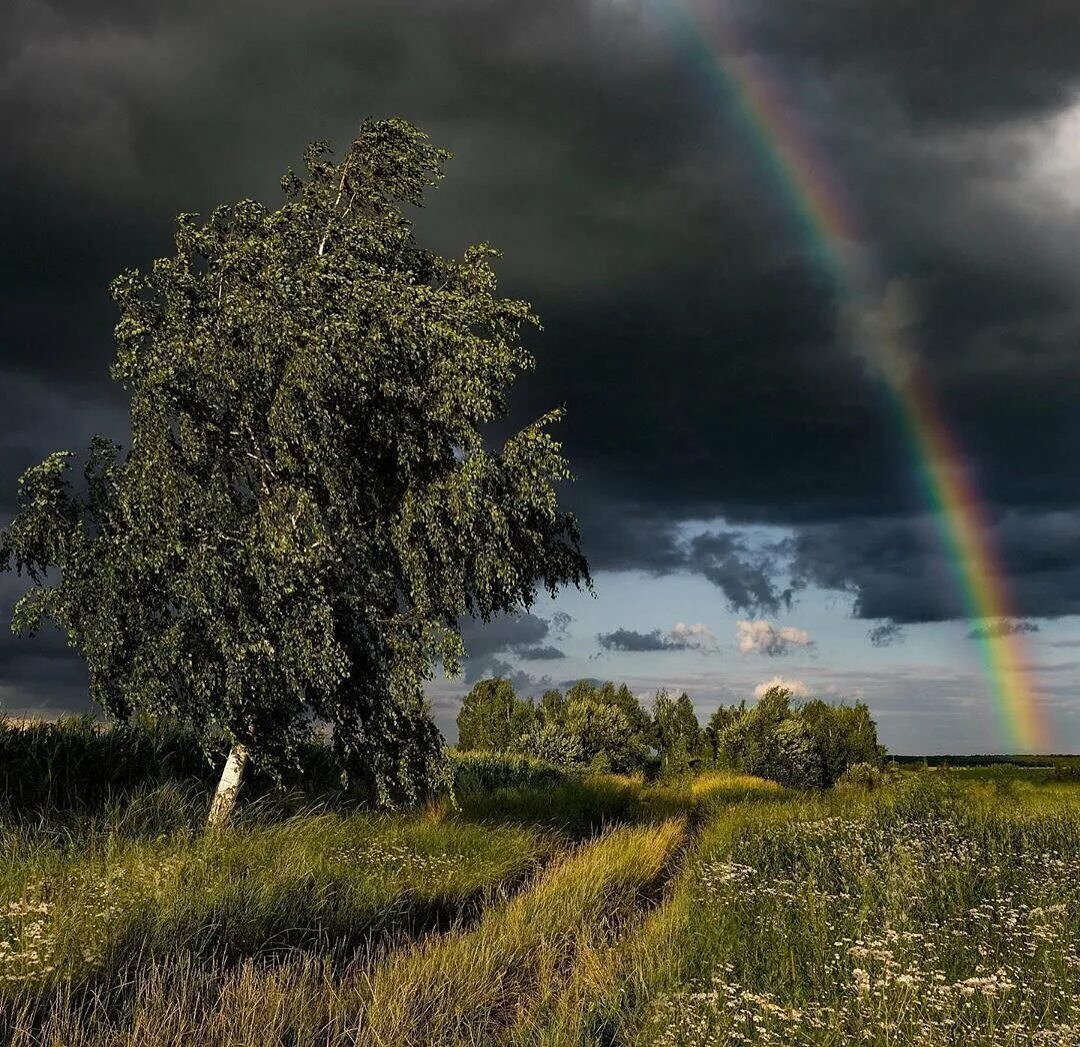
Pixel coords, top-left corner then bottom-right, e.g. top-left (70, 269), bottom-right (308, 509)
top-left (0, 0), bottom-right (1080, 752)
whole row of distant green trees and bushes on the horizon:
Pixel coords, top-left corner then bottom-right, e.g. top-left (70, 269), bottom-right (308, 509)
top-left (457, 677), bottom-right (885, 789)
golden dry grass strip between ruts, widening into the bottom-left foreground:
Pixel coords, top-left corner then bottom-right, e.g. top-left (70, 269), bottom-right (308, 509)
top-left (0, 820), bottom-right (683, 1047)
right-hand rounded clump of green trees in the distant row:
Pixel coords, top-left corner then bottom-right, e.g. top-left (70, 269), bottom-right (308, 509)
top-left (710, 687), bottom-right (885, 789)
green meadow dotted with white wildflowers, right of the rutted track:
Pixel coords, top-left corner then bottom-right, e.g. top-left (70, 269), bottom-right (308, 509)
top-left (548, 773), bottom-right (1080, 1047)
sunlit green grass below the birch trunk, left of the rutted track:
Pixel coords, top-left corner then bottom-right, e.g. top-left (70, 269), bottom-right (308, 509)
top-left (0, 786), bottom-right (554, 995)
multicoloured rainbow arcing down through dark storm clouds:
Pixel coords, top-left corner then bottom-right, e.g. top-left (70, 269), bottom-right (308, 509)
top-left (644, 0), bottom-right (1048, 752)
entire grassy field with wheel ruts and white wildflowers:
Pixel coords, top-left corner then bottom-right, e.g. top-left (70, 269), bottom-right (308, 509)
top-left (0, 766), bottom-right (1080, 1047)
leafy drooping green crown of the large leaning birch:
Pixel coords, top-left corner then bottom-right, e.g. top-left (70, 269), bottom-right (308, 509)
top-left (0, 119), bottom-right (589, 803)
